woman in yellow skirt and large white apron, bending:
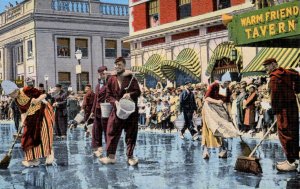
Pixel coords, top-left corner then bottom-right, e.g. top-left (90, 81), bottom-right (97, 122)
top-left (202, 73), bottom-right (241, 159)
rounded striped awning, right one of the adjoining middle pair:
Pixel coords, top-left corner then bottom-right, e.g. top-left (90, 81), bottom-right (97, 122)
top-left (161, 48), bottom-right (201, 81)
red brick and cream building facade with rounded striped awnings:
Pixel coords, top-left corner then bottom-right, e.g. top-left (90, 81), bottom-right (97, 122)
top-left (124, 0), bottom-right (258, 87)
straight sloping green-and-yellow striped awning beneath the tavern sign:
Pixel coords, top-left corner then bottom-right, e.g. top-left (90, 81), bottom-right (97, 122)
top-left (242, 48), bottom-right (300, 77)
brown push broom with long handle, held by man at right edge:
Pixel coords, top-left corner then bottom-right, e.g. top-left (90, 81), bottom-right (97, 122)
top-left (234, 120), bottom-right (276, 175)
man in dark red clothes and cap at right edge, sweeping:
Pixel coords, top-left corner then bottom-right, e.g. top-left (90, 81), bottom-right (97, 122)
top-left (263, 58), bottom-right (300, 172)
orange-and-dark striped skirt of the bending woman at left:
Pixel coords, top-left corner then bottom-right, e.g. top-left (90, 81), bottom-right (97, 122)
top-left (25, 103), bottom-right (55, 161)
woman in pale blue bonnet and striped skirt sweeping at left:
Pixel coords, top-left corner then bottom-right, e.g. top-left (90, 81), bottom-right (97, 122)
top-left (1, 80), bottom-right (54, 167)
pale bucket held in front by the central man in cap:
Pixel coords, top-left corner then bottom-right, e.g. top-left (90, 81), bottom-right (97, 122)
top-left (116, 98), bottom-right (136, 119)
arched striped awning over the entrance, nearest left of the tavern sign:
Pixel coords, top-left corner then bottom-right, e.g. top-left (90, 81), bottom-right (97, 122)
top-left (205, 41), bottom-right (242, 76)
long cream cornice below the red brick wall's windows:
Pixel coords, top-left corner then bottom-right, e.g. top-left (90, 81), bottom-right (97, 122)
top-left (123, 3), bottom-right (253, 42)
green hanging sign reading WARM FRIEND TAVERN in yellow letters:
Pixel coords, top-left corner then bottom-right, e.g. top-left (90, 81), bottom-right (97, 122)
top-left (228, 1), bottom-right (300, 48)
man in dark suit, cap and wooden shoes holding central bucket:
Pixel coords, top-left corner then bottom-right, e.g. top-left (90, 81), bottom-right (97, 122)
top-left (100, 57), bottom-right (141, 166)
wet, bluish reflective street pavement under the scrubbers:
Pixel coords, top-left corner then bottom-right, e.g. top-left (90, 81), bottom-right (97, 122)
top-left (0, 124), bottom-right (300, 189)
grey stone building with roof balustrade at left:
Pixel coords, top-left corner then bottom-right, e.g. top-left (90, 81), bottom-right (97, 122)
top-left (0, 0), bottom-right (130, 91)
